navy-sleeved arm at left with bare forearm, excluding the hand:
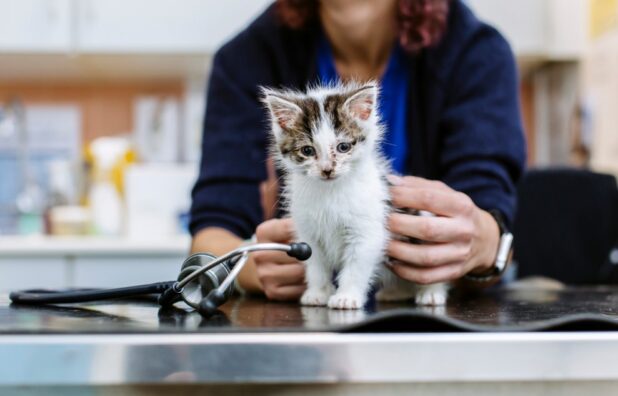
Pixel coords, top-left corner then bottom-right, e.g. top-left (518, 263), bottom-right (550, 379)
top-left (190, 14), bottom-right (273, 254)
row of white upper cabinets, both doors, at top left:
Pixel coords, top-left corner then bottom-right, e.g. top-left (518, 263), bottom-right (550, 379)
top-left (0, 0), bottom-right (271, 54)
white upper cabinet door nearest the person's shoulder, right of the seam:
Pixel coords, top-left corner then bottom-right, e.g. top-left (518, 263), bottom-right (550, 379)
top-left (76, 0), bottom-right (270, 53)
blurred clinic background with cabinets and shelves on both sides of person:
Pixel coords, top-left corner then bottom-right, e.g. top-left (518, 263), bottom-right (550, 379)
top-left (0, 0), bottom-right (618, 286)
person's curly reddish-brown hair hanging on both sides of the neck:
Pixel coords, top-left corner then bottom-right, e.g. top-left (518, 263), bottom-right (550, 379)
top-left (277, 0), bottom-right (450, 52)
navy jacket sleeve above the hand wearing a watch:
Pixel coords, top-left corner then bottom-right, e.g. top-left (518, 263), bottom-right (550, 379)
top-left (439, 26), bottom-right (526, 227)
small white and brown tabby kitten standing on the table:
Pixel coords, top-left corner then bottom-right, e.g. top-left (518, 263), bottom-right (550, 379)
top-left (262, 82), bottom-right (446, 309)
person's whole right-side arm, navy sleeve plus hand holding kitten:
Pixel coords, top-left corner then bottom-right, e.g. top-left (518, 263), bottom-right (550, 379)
top-left (388, 26), bottom-right (525, 287)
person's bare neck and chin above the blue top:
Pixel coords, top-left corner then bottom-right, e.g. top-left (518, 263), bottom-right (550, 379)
top-left (320, 0), bottom-right (397, 80)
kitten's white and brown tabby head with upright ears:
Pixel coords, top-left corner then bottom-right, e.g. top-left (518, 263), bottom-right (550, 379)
top-left (264, 85), bottom-right (378, 181)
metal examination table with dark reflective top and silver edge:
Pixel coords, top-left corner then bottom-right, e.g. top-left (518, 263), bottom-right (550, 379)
top-left (0, 287), bottom-right (618, 386)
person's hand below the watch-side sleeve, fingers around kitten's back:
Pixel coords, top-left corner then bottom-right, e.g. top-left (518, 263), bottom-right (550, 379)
top-left (387, 176), bottom-right (500, 284)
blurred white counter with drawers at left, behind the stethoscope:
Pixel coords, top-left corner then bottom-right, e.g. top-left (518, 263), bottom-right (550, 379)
top-left (0, 236), bottom-right (190, 291)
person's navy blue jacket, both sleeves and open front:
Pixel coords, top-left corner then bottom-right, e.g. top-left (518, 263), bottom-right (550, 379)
top-left (190, 0), bottom-right (525, 238)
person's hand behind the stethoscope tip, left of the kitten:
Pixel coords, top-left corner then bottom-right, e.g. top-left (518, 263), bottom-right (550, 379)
top-left (252, 219), bottom-right (306, 301)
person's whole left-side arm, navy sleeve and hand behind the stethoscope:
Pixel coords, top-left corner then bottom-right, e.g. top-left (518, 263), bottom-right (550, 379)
top-left (190, 7), bottom-right (304, 299)
